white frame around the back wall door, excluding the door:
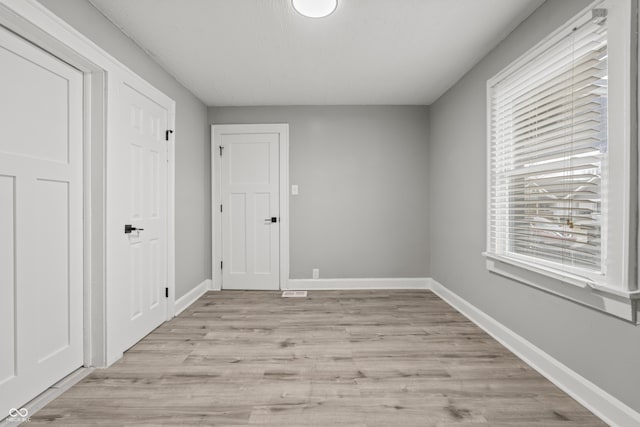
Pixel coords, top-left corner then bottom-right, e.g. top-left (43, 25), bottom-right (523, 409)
top-left (211, 123), bottom-right (289, 291)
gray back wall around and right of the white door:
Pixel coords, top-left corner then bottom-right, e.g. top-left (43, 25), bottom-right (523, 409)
top-left (209, 106), bottom-right (429, 278)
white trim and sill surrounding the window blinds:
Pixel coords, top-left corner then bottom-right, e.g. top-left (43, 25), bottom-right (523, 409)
top-left (483, 0), bottom-right (640, 323)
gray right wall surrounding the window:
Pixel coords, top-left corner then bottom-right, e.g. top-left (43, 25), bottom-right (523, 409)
top-left (429, 0), bottom-right (640, 411)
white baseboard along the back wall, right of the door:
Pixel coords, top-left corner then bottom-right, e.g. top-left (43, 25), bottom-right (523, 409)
top-left (286, 277), bottom-right (429, 291)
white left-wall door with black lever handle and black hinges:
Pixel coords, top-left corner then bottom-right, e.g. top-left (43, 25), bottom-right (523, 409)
top-left (107, 78), bottom-right (168, 357)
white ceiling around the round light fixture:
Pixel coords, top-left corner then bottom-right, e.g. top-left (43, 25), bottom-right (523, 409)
top-left (90, 0), bottom-right (543, 106)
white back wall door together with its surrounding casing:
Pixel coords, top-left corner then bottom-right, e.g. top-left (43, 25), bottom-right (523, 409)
top-left (212, 125), bottom-right (288, 290)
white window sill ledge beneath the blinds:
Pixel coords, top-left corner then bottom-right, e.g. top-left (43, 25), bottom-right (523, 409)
top-left (483, 252), bottom-right (640, 324)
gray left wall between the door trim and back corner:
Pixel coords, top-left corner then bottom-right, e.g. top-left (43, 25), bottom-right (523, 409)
top-left (40, 0), bottom-right (211, 298)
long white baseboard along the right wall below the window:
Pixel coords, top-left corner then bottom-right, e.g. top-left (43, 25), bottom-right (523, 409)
top-left (429, 279), bottom-right (640, 427)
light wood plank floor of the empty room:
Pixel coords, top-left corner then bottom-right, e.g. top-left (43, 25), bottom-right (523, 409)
top-left (29, 291), bottom-right (604, 426)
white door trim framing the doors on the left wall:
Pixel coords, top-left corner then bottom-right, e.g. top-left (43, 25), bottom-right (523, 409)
top-left (0, 0), bottom-right (177, 370)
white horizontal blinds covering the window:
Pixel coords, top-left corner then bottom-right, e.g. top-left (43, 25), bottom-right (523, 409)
top-left (488, 9), bottom-right (608, 273)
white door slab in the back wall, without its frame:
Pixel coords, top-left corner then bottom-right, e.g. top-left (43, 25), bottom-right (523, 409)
top-left (218, 132), bottom-right (280, 290)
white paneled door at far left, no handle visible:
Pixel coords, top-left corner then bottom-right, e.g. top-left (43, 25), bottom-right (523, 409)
top-left (0, 28), bottom-right (83, 418)
